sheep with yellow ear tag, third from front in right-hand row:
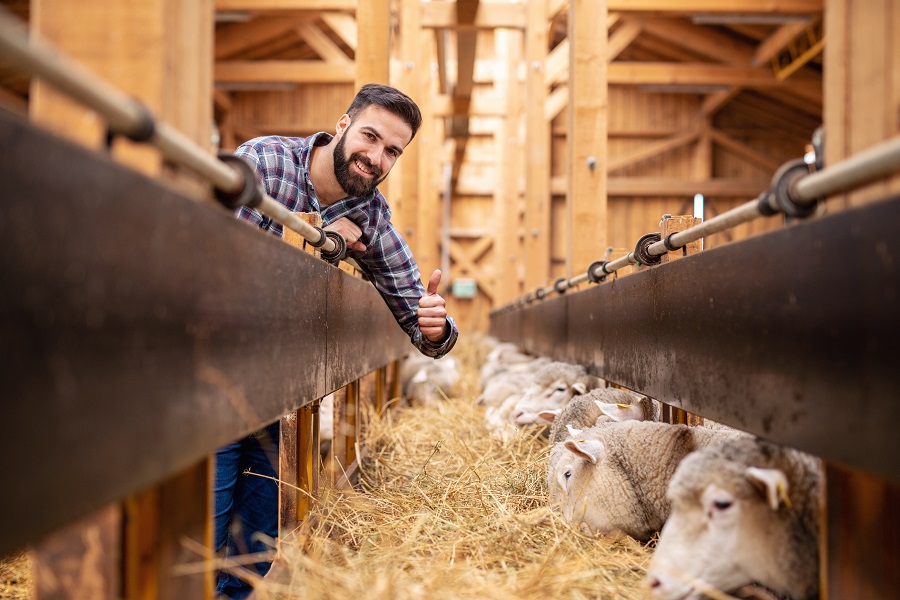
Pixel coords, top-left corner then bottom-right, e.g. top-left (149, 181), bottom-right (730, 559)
top-left (538, 387), bottom-right (656, 445)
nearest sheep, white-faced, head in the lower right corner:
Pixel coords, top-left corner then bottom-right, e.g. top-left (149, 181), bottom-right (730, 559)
top-left (647, 437), bottom-right (823, 600)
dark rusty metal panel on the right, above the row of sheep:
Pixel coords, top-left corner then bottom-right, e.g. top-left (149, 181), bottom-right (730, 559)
top-left (495, 198), bottom-right (900, 482)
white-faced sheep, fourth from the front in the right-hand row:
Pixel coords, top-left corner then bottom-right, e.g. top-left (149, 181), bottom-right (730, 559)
top-left (510, 361), bottom-right (604, 427)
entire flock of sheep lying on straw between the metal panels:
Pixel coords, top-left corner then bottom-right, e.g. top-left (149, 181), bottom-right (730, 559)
top-left (401, 341), bottom-right (822, 600)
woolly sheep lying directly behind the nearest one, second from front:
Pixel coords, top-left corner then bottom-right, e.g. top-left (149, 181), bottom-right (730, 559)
top-left (547, 421), bottom-right (745, 541)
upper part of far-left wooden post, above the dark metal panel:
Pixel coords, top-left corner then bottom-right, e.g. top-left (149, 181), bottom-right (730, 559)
top-left (30, 0), bottom-right (214, 193)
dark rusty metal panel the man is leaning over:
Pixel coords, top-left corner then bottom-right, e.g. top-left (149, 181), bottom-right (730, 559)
top-left (0, 111), bottom-right (408, 553)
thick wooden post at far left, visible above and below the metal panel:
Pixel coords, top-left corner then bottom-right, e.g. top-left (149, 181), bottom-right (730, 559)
top-left (29, 0), bottom-right (214, 599)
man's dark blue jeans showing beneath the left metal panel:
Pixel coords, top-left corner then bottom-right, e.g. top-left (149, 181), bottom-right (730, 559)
top-left (214, 421), bottom-right (279, 600)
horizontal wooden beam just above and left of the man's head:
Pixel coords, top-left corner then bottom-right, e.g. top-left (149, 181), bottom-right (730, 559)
top-left (215, 60), bottom-right (356, 83)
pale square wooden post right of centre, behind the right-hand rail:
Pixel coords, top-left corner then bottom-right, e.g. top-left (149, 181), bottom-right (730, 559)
top-left (566, 0), bottom-right (608, 277)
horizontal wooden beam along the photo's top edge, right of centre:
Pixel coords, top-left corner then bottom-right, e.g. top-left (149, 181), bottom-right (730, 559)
top-left (608, 0), bottom-right (824, 15)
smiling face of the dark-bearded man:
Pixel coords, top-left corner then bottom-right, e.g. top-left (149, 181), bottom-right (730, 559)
top-left (334, 106), bottom-right (412, 196)
